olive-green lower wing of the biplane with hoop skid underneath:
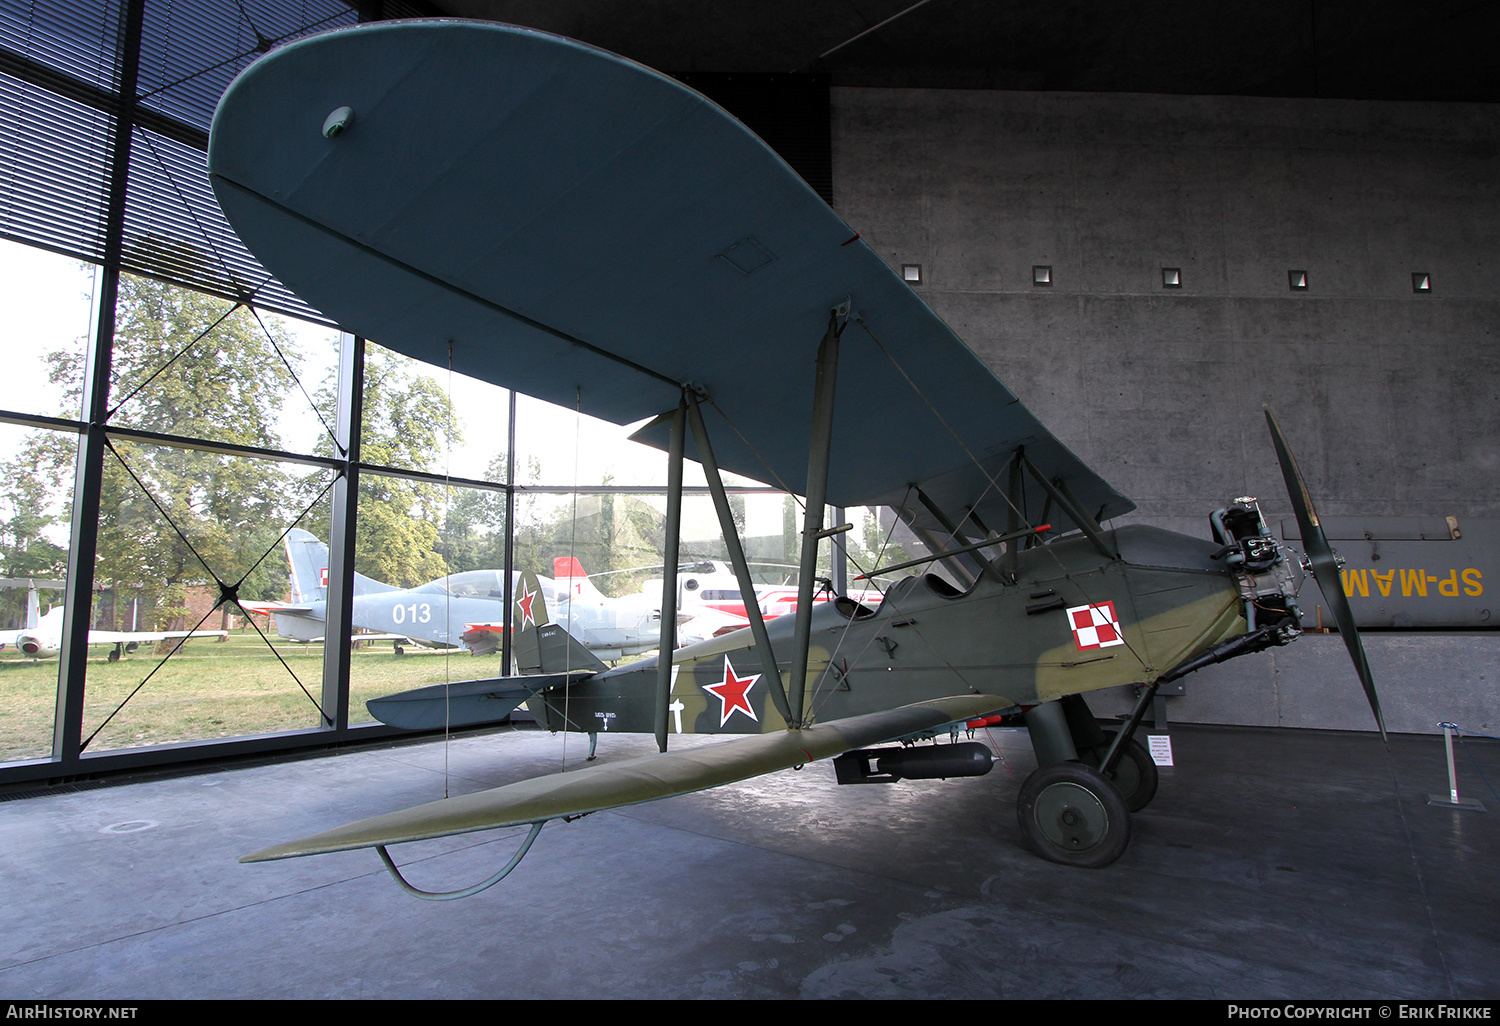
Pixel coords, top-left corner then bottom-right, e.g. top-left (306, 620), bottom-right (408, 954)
top-left (240, 695), bottom-right (1011, 863)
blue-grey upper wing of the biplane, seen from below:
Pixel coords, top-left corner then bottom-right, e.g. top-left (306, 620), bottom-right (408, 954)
top-left (209, 21), bottom-right (1134, 528)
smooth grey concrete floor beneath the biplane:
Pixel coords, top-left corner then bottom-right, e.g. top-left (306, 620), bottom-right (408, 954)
top-left (0, 726), bottom-right (1500, 999)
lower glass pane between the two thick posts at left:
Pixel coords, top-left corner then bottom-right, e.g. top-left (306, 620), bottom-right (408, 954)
top-left (83, 438), bottom-right (332, 753)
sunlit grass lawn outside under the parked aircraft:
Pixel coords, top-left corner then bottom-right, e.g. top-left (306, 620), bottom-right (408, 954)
top-left (0, 632), bottom-right (500, 762)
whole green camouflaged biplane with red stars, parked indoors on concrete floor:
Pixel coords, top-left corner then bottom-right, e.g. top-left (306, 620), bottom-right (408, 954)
top-left (209, 21), bottom-right (1385, 897)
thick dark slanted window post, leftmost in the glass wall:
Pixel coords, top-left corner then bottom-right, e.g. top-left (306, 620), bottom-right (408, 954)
top-left (53, 0), bottom-right (146, 767)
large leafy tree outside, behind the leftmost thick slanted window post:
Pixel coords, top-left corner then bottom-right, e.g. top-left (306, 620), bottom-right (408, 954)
top-left (18, 275), bottom-right (307, 629)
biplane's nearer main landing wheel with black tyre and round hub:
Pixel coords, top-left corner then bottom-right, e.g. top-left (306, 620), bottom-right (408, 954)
top-left (1016, 762), bottom-right (1130, 869)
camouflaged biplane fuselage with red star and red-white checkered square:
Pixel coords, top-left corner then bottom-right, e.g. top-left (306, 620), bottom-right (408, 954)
top-left (528, 525), bottom-right (1245, 734)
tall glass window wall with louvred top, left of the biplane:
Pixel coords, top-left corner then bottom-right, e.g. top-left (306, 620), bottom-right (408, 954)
top-left (0, 0), bottom-right (915, 780)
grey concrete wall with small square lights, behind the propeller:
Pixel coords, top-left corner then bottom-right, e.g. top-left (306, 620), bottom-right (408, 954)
top-left (834, 89), bottom-right (1500, 731)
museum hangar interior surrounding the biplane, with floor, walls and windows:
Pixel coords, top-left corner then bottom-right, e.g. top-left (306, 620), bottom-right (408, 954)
top-left (0, 0), bottom-right (1500, 999)
